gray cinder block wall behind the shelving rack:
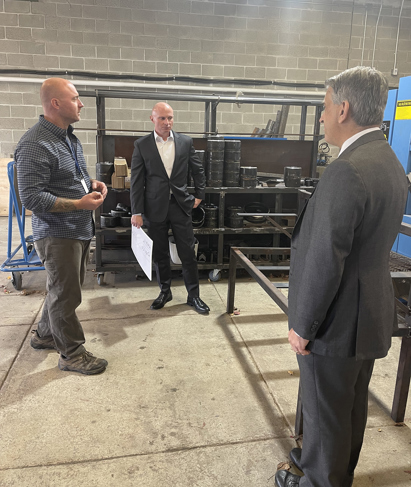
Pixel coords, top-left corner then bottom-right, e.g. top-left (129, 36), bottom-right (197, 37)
top-left (0, 0), bottom-right (411, 168)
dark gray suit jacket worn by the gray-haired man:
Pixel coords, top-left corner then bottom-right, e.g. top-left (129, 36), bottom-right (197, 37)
top-left (288, 131), bottom-right (407, 359)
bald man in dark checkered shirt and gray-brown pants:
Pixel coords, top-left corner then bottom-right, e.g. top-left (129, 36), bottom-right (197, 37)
top-left (15, 78), bottom-right (107, 375)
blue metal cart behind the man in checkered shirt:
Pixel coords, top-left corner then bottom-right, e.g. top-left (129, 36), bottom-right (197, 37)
top-left (0, 161), bottom-right (44, 290)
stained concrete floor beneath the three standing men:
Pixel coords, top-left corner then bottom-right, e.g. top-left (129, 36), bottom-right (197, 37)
top-left (0, 218), bottom-right (411, 487)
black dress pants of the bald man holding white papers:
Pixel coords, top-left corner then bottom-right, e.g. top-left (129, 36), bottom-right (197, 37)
top-left (145, 195), bottom-right (200, 298)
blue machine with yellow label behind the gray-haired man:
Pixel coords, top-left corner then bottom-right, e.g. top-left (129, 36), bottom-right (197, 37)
top-left (382, 76), bottom-right (411, 257)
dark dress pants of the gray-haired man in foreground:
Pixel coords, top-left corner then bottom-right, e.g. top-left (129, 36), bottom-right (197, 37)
top-left (297, 353), bottom-right (374, 487)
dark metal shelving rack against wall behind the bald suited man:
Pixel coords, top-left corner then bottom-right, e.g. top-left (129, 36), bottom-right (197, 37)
top-left (87, 90), bottom-right (322, 284)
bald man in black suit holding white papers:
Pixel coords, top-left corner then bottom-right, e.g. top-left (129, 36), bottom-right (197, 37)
top-left (130, 103), bottom-right (210, 314)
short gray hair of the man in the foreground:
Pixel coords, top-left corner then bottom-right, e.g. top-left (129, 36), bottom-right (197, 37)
top-left (325, 66), bottom-right (388, 127)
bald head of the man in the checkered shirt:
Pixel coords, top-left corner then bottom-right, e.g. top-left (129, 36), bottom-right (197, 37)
top-left (40, 78), bottom-right (84, 129)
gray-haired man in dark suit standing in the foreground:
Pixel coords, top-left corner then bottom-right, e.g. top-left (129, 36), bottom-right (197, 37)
top-left (275, 67), bottom-right (407, 487)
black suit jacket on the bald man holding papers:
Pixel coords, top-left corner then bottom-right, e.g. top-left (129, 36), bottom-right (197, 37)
top-left (130, 132), bottom-right (205, 222)
